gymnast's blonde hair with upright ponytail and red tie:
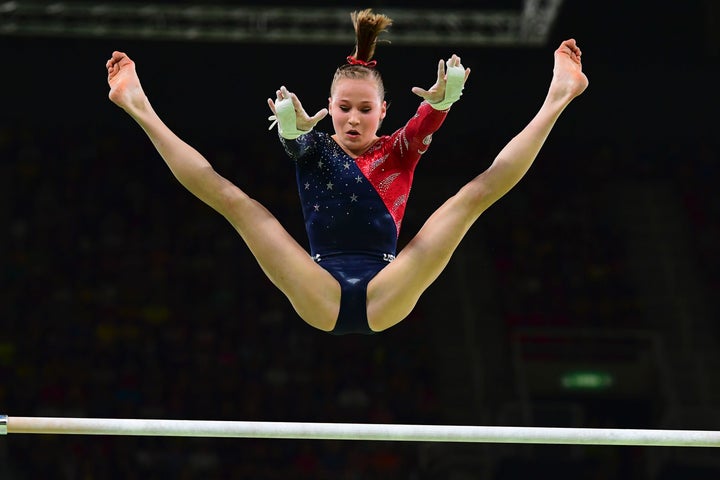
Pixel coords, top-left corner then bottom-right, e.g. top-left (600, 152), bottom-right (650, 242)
top-left (330, 8), bottom-right (392, 100)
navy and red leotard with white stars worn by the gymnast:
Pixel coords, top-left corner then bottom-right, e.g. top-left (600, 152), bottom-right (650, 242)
top-left (281, 102), bottom-right (447, 334)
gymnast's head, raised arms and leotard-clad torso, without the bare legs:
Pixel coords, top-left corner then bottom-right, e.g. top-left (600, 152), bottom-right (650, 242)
top-left (268, 9), bottom-right (470, 333)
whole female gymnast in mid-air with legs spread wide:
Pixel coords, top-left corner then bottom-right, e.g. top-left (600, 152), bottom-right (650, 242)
top-left (106, 9), bottom-right (588, 334)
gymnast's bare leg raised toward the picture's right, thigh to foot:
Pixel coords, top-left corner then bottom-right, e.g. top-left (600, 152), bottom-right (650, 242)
top-left (367, 39), bottom-right (588, 331)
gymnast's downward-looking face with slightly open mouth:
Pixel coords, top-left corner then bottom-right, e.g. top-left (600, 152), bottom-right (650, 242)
top-left (328, 78), bottom-right (387, 158)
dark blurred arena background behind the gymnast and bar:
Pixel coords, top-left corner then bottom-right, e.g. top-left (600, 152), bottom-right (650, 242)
top-left (0, 0), bottom-right (720, 479)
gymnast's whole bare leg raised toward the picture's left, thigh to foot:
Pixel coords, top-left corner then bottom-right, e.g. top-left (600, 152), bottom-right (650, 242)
top-left (106, 52), bottom-right (340, 331)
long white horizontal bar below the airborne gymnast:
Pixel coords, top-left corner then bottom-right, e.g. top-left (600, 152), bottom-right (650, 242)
top-left (0, 417), bottom-right (720, 447)
